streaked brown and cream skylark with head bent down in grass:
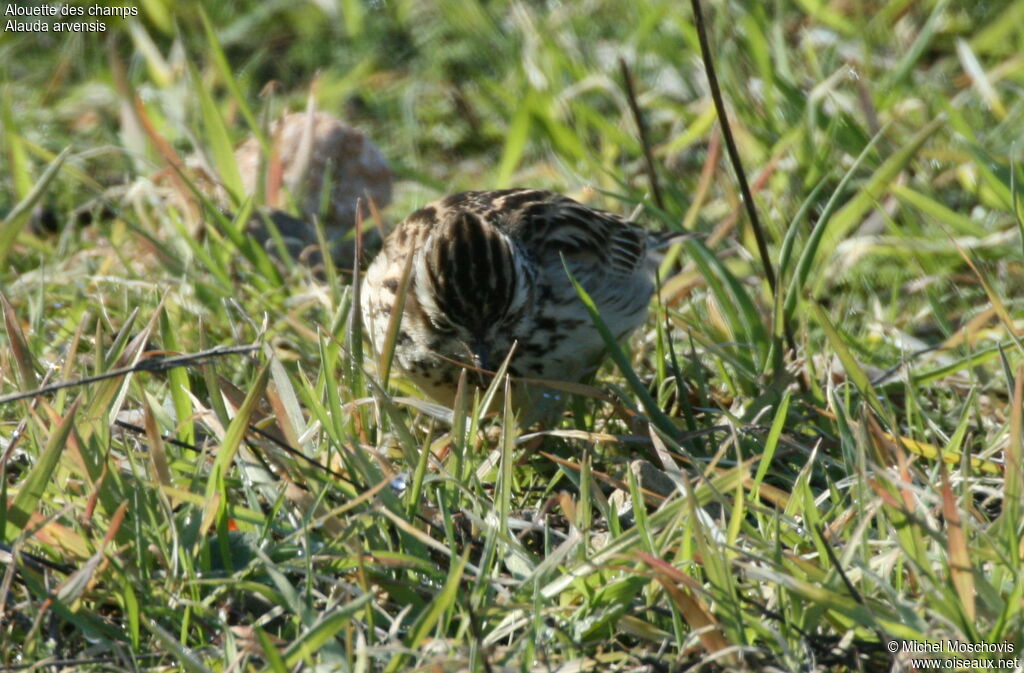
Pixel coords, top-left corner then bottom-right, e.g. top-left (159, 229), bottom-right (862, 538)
top-left (359, 188), bottom-right (678, 423)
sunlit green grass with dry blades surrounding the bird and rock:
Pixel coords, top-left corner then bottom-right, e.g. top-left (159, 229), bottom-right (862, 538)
top-left (0, 0), bottom-right (1024, 672)
